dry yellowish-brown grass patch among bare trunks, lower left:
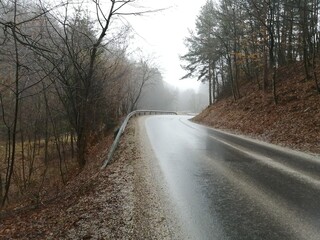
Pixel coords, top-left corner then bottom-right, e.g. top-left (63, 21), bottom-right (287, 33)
top-left (0, 136), bottom-right (79, 210)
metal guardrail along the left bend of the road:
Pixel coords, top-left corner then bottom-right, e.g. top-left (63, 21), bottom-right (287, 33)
top-left (101, 110), bottom-right (178, 169)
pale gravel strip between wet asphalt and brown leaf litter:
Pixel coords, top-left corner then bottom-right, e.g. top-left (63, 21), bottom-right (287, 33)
top-left (60, 117), bottom-right (185, 240)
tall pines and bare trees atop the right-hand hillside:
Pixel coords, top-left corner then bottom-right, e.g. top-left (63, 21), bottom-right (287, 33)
top-left (181, 0), bottom-right (320, 104)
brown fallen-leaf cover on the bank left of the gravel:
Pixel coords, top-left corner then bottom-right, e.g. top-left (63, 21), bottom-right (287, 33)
top-left (0, 131), bottom-right (115, 239)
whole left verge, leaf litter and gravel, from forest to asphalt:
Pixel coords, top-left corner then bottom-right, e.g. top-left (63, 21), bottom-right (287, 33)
top-left (0, 119), bottom-right (178, 240)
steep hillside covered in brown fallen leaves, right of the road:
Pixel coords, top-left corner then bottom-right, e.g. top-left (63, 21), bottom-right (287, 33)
top-left (193, 63), bottom-right (320, 154)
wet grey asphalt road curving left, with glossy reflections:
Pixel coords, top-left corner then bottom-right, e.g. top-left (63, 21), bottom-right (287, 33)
top-left (145, 116), bottom-right (320, 240)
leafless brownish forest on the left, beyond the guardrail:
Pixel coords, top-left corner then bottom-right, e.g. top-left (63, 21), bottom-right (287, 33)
top-left (0, 0), bottom-right (175, 207)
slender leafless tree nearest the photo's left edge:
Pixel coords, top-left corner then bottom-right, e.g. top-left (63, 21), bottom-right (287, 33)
top-left (0, 0), bottom-right (52, 206)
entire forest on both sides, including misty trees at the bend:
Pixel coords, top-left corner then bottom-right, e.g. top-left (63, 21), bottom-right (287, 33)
top-left (0, 0), bottom-right (320, 212)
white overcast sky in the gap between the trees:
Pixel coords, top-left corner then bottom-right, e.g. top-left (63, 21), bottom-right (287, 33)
top-left (122, 0), bottom-right (206, 89)
